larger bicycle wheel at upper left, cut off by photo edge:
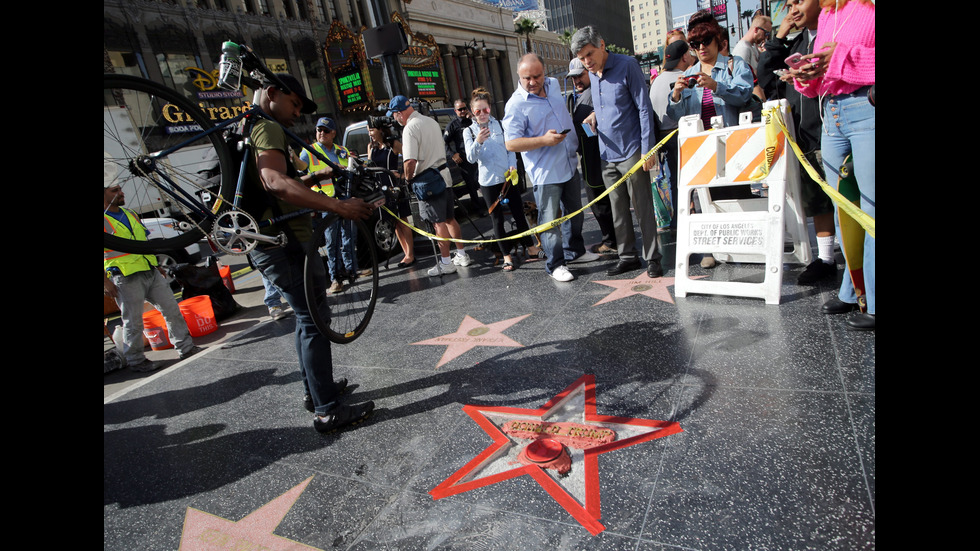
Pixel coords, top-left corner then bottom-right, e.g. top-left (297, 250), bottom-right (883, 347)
top-left (103, 74), bottom-right (232, 254)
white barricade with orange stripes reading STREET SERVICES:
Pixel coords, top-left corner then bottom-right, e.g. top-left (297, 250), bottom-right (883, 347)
top-left (674, 100), bottom-right (811, 304)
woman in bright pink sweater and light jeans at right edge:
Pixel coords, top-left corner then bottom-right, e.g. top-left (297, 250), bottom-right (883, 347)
top-left (791, 0), bottom-right (875, 331)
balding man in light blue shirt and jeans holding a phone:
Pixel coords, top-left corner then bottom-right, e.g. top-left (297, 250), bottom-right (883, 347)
top-left (504, 53), bottom-right (599, 281)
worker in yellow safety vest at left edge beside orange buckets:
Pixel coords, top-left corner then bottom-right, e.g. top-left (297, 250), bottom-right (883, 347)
top-left (102, 184), bottom-right (201, 372)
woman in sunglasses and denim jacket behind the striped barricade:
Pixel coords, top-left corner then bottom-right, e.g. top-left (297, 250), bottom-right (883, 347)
top-left (667, 19), bottom-right (753, 129)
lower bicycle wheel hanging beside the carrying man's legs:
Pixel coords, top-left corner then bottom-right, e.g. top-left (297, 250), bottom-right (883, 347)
top-left (303, 215), bottom-right (378, 344)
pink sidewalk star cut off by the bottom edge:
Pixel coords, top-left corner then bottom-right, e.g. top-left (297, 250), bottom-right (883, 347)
top-left (180, 476), bottom-right (317, 551)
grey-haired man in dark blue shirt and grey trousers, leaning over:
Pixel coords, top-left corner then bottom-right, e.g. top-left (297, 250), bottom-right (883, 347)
top-left (571, 26), bottom-right (663, 277)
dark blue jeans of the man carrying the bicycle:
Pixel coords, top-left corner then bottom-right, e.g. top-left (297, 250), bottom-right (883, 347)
top-left (250, 247), bottom-right (337, 415)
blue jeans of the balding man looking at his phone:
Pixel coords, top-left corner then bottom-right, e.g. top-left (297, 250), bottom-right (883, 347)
top-left (534, 171), bottom-right (585, 274)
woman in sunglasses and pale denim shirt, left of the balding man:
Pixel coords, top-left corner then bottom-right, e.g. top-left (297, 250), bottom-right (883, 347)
top-left (463, 88), bottom-right (540, 272)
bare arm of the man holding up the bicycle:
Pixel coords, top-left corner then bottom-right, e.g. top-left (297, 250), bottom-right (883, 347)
top-left (256, 149), bottom-right (371, 219)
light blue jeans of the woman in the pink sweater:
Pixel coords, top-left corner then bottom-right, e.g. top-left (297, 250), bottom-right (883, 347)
top-left (820, 88), bottom-right (875, 314)
